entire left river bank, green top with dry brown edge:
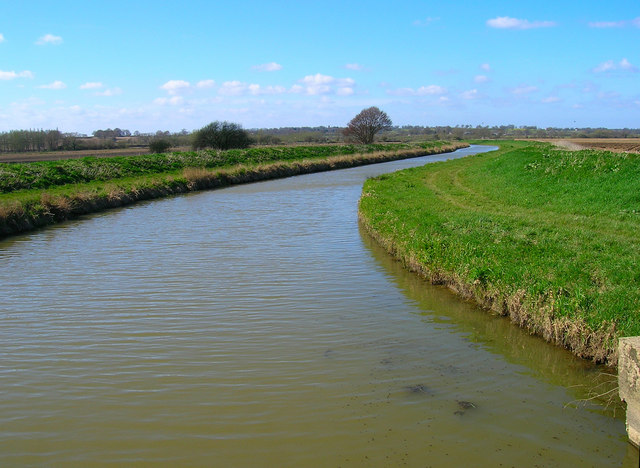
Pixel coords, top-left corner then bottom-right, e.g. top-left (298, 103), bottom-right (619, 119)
top-left (0, 141), bottom-right (468, 237)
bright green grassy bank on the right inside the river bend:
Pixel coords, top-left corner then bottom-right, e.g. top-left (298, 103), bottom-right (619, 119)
top-left (360, 142), bottom-right (640, 364)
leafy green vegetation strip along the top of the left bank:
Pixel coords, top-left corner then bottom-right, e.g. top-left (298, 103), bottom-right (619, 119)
top-left (0, 142), bottom-right (442, 193)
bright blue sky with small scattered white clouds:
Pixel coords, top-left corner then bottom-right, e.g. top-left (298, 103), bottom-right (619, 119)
top-left (0, 0), bottom-right (640, 133)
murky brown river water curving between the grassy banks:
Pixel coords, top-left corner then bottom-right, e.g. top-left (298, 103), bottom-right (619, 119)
top-left (0, 145), bottom-right (638, 467)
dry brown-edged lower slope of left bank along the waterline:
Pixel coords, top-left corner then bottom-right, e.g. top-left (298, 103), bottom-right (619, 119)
top-left (0, 143), bottom-right (469, 238)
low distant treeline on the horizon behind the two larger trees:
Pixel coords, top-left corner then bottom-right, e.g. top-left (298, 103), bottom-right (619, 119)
top-left (0, 125), bottom-right (640, 153)
